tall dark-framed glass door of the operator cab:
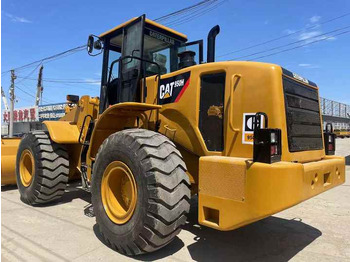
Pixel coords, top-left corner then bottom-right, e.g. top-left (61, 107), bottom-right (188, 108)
top-left (117, 15), bottom-right (145, 103)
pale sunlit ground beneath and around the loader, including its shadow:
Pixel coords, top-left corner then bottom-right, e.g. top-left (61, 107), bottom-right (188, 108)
top-left (1, 138), bottom-right (350, 262)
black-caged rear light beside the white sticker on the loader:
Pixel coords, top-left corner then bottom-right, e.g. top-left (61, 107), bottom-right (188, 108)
top-left (253, 112), bottom-right (282, 164)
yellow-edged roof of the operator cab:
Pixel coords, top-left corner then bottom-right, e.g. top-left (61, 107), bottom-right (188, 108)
top-left (99, 17), bottom-right (187, 42)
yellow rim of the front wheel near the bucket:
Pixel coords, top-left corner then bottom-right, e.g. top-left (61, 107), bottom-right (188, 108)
top-left (19, 149), bottom-right (35, 187)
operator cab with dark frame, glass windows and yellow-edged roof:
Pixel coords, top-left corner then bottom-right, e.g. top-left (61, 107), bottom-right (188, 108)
top-left (88, 15), bottom-right (203, 113)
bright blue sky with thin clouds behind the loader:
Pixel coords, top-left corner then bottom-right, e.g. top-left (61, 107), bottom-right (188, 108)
top-left (1, 0), bottom-right (350, 107)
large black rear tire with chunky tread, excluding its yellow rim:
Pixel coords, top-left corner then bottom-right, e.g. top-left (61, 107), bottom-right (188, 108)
top-left (91, 129), bottom-right (190, 256)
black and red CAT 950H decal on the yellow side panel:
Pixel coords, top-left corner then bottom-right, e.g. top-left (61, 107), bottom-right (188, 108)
top-left (158, 72), bottom-right (191, 105)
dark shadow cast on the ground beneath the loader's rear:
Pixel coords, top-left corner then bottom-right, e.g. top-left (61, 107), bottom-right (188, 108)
top-left (94, 196), bottom-right (322, 261)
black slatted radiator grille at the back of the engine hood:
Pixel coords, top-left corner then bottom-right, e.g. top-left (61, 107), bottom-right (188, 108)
top-left (283, 76), bottom-right (323, 152)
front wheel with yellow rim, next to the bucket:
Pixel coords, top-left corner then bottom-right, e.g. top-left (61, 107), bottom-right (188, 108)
top-left (16, 131), bottom-right (69, 205)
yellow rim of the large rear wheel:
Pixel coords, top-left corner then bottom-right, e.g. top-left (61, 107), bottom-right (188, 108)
top-left (101, 161), bottom-right (137, 225)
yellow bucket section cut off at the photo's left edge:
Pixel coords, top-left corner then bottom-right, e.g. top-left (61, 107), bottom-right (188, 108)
top-left (1, 138), bottom-right (21, 185)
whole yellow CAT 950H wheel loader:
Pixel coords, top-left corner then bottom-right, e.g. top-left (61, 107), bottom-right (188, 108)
top-left (1, 15), bottom-right (345, 256)
